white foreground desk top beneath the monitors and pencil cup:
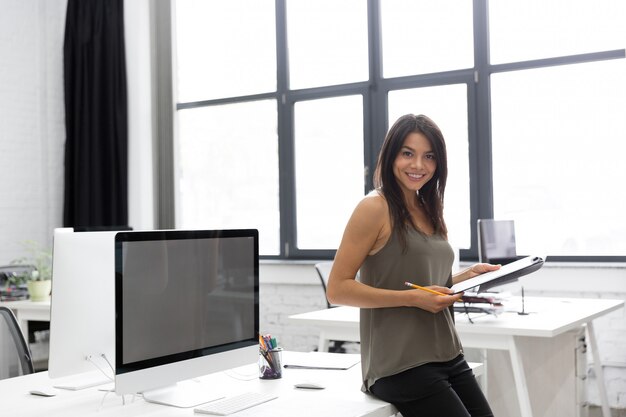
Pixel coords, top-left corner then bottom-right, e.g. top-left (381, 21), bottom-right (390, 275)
top-left (0, 352), bottom-right (397, 417)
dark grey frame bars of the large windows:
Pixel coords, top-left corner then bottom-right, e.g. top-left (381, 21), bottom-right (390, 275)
top-left (152, 0), bottom-right (626, 261)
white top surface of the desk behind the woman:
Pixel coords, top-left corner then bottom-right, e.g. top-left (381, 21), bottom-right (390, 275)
top-left (289, 297), bottom-right (624, 339)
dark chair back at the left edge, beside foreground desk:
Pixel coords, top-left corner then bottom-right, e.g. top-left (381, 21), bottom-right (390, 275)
top-left (0, 307), bottom-right (35, 379)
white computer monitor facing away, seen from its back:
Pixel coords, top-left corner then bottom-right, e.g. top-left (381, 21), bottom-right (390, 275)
top-left (48, 228), bottom-right (116, 380)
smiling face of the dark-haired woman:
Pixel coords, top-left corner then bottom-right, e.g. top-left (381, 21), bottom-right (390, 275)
top-left (393, 132), bottom-right (437, 201)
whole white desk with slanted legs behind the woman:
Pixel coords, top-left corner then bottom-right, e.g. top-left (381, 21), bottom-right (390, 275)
top-left (289, 297), bottom-right (624, 417)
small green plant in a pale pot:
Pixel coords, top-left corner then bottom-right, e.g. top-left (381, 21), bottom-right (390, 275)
top-left (9, 241), bottom-right (52, 301)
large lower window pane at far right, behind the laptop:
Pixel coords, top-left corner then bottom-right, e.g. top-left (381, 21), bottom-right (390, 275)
top-left (492, 60), bottom-right (626, 256)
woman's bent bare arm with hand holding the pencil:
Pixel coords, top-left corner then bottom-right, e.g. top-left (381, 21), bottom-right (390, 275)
top-left (326, 196), bottom-right (461, 313)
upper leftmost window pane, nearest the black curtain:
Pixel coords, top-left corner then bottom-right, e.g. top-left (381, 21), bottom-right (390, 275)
top-left (175, 0), bottom-right (276, 103)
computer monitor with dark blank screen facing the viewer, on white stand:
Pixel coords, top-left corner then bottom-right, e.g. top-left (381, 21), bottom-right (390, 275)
top-left (115, 229), bottom-right (259, 407)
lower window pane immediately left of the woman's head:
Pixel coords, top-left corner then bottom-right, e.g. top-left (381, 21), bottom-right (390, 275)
top-left (294, 96), bottom-right (365, 249)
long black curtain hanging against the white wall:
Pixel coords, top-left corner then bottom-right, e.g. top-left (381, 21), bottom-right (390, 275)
top-left (63, 0), bottom-right (128, 228)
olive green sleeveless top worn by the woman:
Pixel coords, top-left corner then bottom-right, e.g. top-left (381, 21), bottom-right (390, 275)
top-left (360, 228), bottom-right (462, 390)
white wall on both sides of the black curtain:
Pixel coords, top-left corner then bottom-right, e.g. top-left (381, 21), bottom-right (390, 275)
top-left (0, 0), bottom-right (154, 265)
